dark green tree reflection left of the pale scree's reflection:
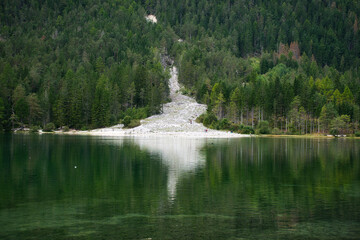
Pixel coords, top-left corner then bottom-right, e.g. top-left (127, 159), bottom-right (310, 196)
top-left (0, 136), bottom-right (167, 214)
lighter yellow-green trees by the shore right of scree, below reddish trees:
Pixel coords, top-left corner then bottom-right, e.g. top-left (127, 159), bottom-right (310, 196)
top-left (180, 44), bottom-right (360, 134)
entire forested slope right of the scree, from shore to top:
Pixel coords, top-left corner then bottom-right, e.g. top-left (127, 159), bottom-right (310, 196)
top-left (157, 1), bottom-right (360, 134)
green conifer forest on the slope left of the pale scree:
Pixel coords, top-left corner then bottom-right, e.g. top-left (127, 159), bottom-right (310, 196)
top-left (0, 0), bottom-right (169, 129)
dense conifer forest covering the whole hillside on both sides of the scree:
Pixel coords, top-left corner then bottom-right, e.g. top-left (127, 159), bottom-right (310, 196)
top-left (0, 0), bottom-right (360, 134)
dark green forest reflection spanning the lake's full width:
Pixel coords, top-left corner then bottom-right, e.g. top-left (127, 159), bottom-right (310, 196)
top-left (0, 135), bottom-right (360, 237)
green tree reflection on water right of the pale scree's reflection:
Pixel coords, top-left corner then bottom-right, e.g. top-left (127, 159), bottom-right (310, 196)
top-left (174, 138), bottom-right (360, 232)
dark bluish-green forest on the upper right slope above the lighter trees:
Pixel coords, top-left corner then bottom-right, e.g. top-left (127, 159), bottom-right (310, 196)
top-left (159, 0), bottom-right (360, 69)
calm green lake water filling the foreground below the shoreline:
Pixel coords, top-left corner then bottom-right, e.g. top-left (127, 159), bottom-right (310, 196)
top-left (0, 134), bottom-right (360, 240)
